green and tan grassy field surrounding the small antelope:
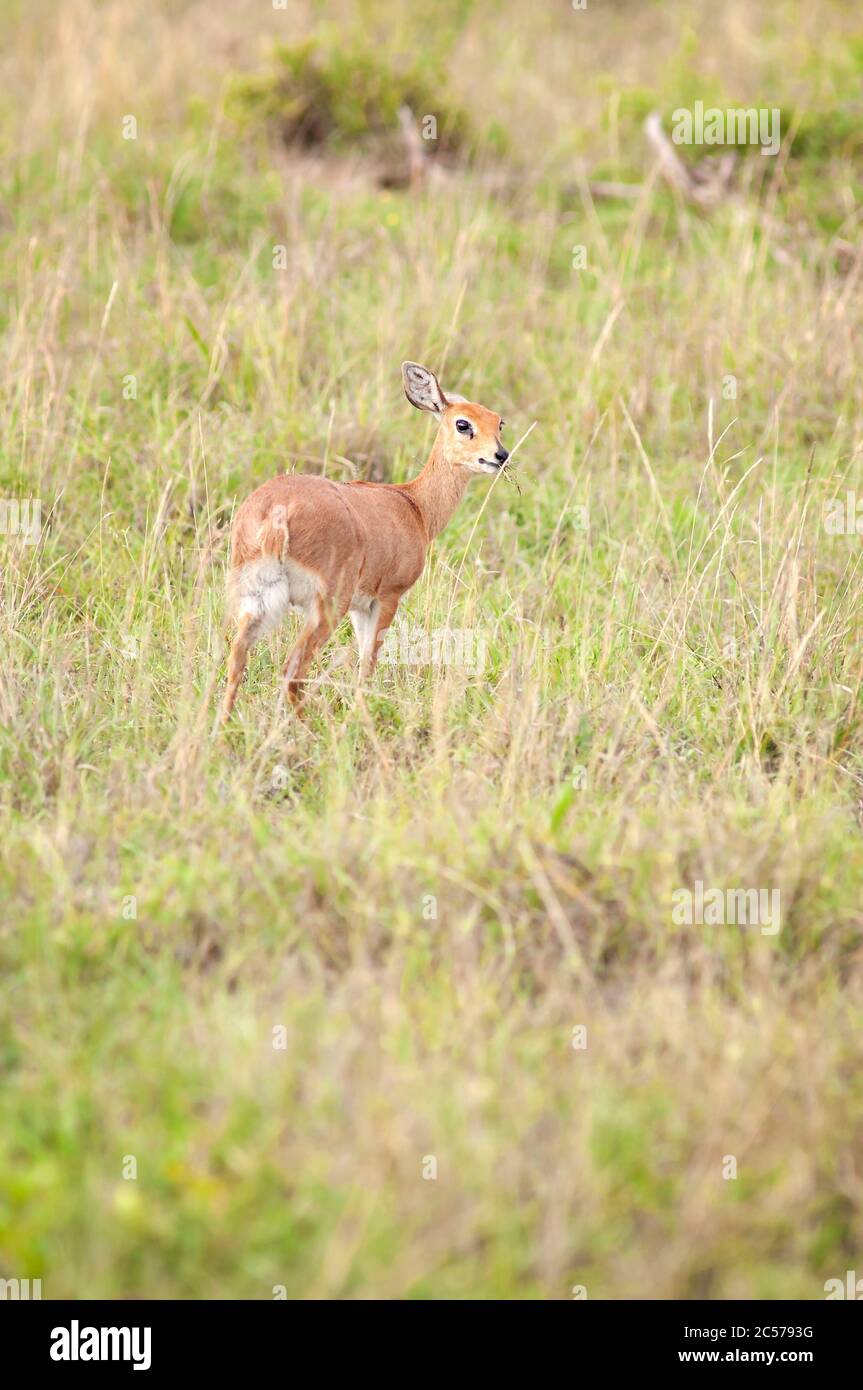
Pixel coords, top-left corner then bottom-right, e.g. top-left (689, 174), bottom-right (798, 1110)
top-left (0, 0), bottom-right (863, 1298)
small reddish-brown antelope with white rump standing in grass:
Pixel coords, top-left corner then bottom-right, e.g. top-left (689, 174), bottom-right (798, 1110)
top-left (222, 361), bottom-right (509, 719)
